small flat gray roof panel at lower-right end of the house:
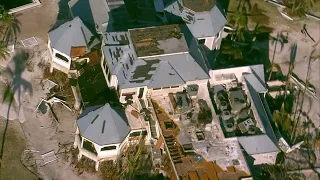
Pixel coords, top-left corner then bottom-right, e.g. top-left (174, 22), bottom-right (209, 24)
top-left (238, 134), bottom-right (279, 155)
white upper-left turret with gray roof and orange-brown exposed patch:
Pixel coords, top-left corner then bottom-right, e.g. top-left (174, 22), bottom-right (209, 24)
top-left (48, 17), bottom-right (99, 74)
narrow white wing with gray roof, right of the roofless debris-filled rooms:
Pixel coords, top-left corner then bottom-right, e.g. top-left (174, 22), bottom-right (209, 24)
top-left (210, 65), bottom-right (280, 165)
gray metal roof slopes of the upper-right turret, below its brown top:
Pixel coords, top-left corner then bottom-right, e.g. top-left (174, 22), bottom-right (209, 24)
top-left (187, 6), bottom-right (227, 38)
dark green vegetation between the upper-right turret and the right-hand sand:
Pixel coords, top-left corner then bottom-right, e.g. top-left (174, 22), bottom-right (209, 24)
top-left (212, 1), bottom-right (273, 69)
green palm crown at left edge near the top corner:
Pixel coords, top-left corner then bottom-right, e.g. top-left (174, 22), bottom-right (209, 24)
top-left (0, 6), bottom-right (20, 45)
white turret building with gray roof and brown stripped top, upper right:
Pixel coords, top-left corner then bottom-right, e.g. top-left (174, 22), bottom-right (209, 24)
top-left (164, 0), bottom-right (227, 50)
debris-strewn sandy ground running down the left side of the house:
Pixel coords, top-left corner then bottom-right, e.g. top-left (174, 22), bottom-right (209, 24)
top-left (0, 0), bottom-right (98, 180)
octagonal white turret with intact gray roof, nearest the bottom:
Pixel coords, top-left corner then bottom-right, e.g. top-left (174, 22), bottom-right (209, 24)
top-left (74, 104), bottom-right (150, 170)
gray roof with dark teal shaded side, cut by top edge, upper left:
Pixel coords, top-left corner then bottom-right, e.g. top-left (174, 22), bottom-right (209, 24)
top-left (69, 0), bottom-right (110, 32)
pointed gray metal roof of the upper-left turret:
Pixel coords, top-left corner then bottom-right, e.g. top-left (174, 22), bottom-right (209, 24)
top-left (49, 17), bottom-right (97, 56)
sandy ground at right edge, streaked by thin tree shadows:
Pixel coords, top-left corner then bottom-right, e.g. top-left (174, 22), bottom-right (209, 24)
top-left (269, 20), bottom-right (320, 127)
